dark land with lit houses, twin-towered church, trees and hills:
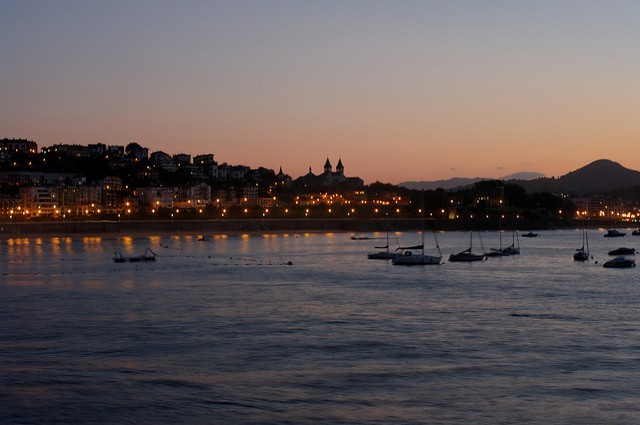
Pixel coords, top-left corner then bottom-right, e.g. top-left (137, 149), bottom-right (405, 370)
top-left (0, 139), bottom-right (640, 227)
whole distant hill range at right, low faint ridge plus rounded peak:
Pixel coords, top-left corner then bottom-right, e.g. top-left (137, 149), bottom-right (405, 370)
top-left (399, 159), bottom-right (640, 195)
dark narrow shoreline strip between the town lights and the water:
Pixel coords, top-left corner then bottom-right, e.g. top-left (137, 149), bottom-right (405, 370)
top-left (0, 218), bottom-right (638, 239)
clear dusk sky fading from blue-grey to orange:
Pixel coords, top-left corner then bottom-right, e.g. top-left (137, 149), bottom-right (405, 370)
top-left (0, 0), bottom-right (640, 184)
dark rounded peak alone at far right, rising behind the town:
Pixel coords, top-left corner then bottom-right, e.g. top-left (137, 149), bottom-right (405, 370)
top-left (509, 159), bottom-right (640, 195)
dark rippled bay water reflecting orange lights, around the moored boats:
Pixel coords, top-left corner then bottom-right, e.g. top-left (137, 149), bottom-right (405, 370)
top-left (0, 229), bottom-right (640, 424)
